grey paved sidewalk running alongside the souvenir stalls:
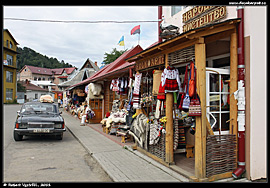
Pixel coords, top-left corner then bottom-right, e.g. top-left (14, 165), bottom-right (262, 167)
top-left (62, 112), bottom-right (189, 182)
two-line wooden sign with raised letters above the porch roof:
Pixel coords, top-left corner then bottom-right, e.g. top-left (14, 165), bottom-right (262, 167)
top-left (182, 6), bottom-right (226, 32)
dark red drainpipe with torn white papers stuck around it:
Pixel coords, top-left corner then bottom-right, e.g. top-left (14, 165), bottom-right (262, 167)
top-left (232, 6), bottom-right (246, 178)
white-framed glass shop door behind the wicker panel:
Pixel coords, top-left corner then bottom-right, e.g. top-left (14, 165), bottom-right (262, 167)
top-left (206, 67), bottom-right (230, 135)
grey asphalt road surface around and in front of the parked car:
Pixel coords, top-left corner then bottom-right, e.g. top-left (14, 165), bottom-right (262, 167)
top-left (3, 105), bottom-right (112, 182)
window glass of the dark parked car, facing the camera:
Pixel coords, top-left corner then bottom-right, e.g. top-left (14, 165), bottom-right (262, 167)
top-left (21, 103), bottom-right (57, 115)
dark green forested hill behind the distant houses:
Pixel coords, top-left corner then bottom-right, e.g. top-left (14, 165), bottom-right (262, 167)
top-left (17, 47), bottom-right (72, 70)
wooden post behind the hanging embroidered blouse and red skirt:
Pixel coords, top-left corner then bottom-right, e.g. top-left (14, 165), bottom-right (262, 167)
top-left (165, 54), bottom-right (174, 164)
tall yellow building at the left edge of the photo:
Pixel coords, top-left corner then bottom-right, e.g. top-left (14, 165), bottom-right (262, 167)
top-left (3, 29), bottom-right (18, 103)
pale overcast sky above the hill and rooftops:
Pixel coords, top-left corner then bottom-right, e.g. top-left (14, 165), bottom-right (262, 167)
top-left (4, 6), bottom-right (158, 68)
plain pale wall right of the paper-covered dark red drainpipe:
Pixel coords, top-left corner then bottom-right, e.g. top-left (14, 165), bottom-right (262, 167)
top-left (245, 6), bottom-right (267, 180)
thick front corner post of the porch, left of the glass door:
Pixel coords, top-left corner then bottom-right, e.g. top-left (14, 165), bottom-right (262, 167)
top-left (195, 41), bottom-right (207, 178)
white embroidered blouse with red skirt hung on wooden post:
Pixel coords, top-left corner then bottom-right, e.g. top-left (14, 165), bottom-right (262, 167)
top-left (161, 66), bottom-right (181, 93)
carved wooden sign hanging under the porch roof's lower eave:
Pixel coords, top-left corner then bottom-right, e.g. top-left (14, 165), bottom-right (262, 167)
top-left (135, 55), bottom-right (165, 71)
